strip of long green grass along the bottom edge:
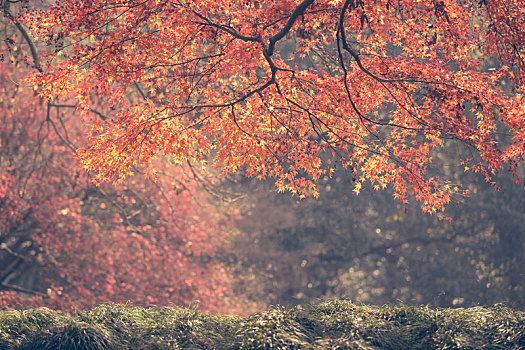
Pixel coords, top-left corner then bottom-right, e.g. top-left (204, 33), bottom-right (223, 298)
top-left (0, 299), bottom-right (525, 350)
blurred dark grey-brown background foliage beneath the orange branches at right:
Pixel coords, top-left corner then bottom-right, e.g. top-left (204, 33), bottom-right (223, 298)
top-left (227, 148), bottom-right (525, 309)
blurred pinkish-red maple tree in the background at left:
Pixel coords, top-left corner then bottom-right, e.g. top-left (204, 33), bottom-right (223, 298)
top-left (0, 15), bottom-right (246, 313)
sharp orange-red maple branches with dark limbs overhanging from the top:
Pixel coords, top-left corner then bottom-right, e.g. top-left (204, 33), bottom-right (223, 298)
top-left (13, 0), bottom-right (525, 213)
